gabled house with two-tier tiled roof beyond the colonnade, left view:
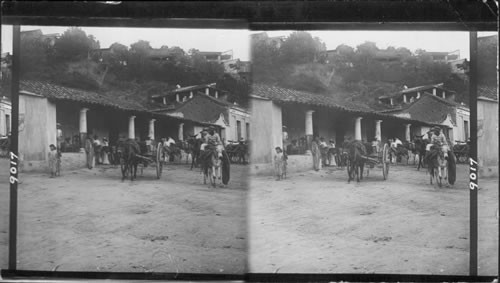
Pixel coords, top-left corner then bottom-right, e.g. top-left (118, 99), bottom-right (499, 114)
top-left (151, 83), bottom-right (250, 141)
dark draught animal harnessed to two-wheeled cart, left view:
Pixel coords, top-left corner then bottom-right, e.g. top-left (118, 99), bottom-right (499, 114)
top-left (120, 143), bottom-right (167, 180)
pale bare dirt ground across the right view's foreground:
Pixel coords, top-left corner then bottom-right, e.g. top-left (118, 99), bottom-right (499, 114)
top-left (248, 165), bottom-right (499, 275)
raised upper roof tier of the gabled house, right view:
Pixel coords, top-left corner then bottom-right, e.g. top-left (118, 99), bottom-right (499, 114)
top-left (378, 83), bottom-right (456, 106)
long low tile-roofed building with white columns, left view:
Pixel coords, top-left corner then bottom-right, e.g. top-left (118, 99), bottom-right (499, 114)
top-left (19, 80), bottom-right (216, 171)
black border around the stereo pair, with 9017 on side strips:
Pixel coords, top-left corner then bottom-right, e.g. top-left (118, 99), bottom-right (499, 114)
top-left (1, 0), bottom-right (498, 282)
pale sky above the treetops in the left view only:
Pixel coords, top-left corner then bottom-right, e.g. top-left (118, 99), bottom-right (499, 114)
top-left (2, 25), bottom-right (250, 61)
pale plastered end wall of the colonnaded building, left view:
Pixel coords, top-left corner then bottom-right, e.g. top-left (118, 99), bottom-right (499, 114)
top-left (19, 95), bottom-right (56, 172)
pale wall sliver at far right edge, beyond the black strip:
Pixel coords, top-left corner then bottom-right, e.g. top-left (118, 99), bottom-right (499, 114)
top-left (477, 100), bottom-right (498, 177)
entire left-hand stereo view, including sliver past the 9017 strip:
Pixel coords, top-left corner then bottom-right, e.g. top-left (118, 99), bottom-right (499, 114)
top-left (0, 25), bottom-right (250, 274)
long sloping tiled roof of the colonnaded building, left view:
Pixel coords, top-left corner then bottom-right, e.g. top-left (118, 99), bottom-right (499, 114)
top-left (19, 80), bottom-right (147, 111)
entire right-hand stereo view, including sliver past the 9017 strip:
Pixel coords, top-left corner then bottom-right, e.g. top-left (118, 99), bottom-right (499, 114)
top-left (248, 30), bottom-right (498, 275)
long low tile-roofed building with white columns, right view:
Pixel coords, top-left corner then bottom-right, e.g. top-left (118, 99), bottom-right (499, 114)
top-left (250, 84), bottom-right (430, 173)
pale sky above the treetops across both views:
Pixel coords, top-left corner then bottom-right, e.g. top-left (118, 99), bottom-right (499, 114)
top-left (2, 26), bottom-right (495, 61)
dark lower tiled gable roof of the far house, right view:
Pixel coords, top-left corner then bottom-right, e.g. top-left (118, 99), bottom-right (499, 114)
top-left (386, 93), bottom-right (458, 124)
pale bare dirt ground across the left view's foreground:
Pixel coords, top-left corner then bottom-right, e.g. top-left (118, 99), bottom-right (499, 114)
top-left (0, 159), bottom-right (247, 274)
